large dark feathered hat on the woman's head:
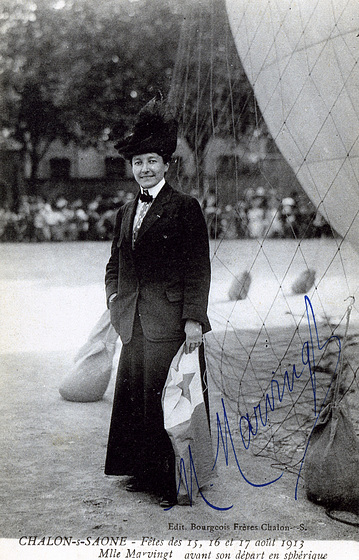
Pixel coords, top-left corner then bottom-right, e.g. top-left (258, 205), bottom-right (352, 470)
top-left (115, 97), bottom-right (178, 161)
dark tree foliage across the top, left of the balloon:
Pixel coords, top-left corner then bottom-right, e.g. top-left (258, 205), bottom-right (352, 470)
top-left (0, 0), bottom-right (262, 192)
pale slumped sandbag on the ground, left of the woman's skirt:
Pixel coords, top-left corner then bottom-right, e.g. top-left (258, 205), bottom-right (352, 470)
top-left (59, 310), bottom-right (118, 402)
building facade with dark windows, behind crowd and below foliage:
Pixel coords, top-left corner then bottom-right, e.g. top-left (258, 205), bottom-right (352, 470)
top-left (0, 134), bottom-right (299, 205)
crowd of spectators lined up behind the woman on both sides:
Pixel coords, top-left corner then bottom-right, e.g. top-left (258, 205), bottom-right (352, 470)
top-left (0, 188), bottom-right (332, 242)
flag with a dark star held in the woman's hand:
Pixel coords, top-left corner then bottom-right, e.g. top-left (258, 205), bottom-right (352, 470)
top-left (162, 344), bottom-right (214, 502)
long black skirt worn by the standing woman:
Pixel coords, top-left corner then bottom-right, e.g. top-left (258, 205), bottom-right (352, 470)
top-left (105, 317), bottom-right (183, 489)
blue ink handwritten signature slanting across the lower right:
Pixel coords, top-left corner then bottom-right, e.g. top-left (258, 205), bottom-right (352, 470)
top-left (167, 296), bottom-right (341, 511)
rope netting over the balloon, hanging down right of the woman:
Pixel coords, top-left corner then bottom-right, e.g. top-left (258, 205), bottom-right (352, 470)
top-left (169, 0), bottom-right (359, 480)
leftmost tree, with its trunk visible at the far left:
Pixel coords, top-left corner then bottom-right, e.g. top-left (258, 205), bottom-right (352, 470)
top-left (0, 1), bottom-right (80, 192)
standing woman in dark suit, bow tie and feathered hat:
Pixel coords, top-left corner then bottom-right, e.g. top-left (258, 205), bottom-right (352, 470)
top-left (105, 100), bottom-right (210, 507)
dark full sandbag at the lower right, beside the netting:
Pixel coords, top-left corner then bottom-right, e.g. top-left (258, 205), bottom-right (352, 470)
top-left (304, 401), bottom-right (359, 515)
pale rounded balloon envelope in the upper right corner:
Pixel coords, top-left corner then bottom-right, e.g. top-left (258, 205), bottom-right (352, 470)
top-left (226, 0), bottom-right (359, 251)
